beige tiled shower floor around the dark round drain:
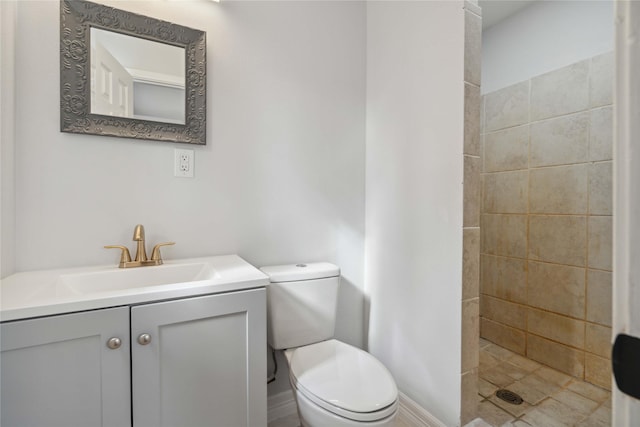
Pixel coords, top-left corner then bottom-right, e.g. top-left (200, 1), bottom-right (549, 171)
top-left (478, 339), bottom-right (611, 427)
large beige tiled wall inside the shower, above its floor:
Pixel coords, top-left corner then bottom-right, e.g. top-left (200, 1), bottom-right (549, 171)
top-left (480, 53), bottom-right (613, 389)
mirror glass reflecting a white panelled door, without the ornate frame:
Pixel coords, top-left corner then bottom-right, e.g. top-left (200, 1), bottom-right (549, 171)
top-left (90, 27), bottom-right (186, 124)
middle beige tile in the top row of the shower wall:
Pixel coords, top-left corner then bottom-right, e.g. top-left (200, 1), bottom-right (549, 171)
top-left (531, 60), bottom-right (589, 120)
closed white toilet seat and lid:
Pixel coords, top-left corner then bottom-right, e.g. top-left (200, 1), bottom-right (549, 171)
top-left (285, 339), bottom-right (398, 421)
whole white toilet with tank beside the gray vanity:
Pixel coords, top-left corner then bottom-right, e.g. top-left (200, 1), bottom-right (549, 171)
top-left (261, 262), bottom-right (398, 427)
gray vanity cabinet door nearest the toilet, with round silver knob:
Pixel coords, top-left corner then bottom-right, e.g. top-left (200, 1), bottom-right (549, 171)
top-left (131, 289), bottom-right (267, 427)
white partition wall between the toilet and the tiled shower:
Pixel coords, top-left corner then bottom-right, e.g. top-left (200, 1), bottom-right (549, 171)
top-left (365, 1), bottom-right (464, 425)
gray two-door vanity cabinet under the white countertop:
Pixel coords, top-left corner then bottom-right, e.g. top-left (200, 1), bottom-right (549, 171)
top-left (0, 288), bottom-right (267, 427)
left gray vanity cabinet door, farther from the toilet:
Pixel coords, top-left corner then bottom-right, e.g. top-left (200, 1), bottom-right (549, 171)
top-left (0, 307), bottom-right (131, 427)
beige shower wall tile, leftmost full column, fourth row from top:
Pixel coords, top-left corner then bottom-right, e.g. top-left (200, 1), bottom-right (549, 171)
top-left (480, 214), bottom-right (527, 258)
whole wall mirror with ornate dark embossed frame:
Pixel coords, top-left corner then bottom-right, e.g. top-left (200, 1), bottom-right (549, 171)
top-left (60, 0), bottom-right (206, 145)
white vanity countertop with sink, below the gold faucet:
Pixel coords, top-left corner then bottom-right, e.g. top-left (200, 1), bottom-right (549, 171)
top-left (0, 255), bottom-right (269, 321)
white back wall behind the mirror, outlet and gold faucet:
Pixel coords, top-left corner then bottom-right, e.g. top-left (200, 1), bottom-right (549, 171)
top-left (3, 0), bottom-right (366, 392)
